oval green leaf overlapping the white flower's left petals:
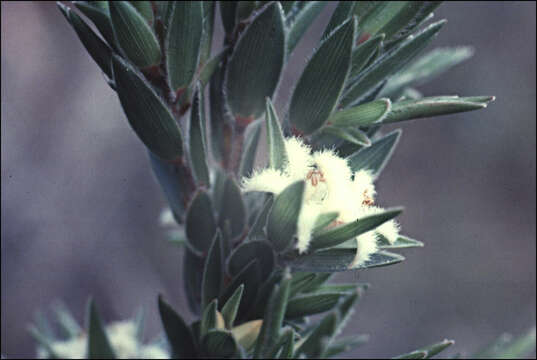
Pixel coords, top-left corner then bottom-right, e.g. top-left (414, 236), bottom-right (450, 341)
top-left (267, 181), bottom-right (305, 252)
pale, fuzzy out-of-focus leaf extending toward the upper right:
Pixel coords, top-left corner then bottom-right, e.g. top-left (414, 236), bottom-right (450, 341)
top-left (380, 46), bottom-right (474, 96)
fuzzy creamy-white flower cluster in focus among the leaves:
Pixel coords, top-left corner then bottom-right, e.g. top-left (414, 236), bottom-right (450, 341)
top-left (242, 137), bottom-right (399, 267)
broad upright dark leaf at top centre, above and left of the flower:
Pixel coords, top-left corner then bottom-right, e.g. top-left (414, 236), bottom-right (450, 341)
top-left (225, 1), bottom-right (285, 123)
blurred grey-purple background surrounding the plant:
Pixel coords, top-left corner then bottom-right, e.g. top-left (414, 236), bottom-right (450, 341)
top-left (0, 2), bottom-right (536, 357)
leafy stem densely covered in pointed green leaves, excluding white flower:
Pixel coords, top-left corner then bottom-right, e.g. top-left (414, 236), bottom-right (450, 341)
top-left (50, 1), bottom-right (520, 358)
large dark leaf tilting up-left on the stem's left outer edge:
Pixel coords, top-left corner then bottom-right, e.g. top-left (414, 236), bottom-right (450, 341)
top-left (112, 56), bottom-right (183, 160)
